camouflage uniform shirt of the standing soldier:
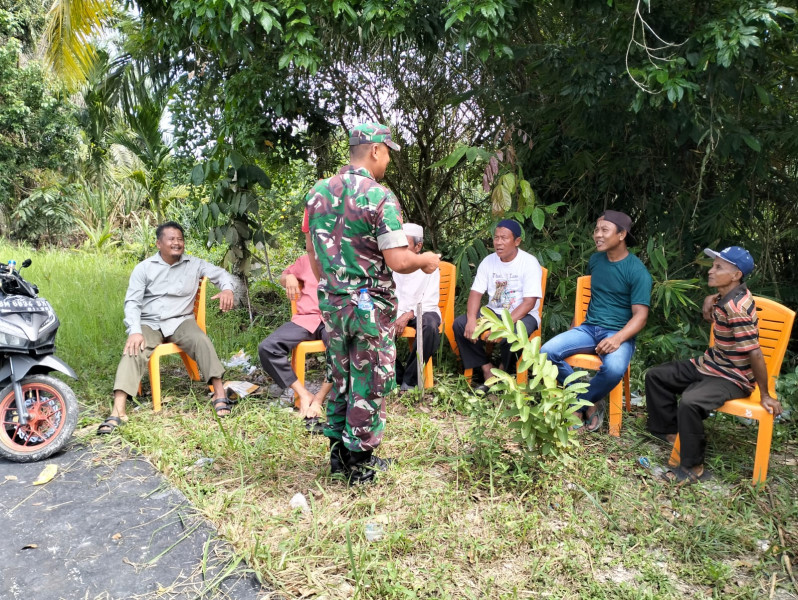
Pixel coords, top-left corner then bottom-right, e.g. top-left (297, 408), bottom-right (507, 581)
top-left (305, 165), bottom-right (407, 313)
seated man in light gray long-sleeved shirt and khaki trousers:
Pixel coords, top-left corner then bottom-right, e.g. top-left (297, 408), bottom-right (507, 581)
top-left (97, 221), bottom-right (234, 435)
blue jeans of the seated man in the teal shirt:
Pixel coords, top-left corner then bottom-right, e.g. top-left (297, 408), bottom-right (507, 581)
top-left (540, 325), bottom-right (635, 404)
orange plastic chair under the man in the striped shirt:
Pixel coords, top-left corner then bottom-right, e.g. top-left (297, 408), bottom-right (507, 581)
top-left (668, 296), bottom-right (795, 485)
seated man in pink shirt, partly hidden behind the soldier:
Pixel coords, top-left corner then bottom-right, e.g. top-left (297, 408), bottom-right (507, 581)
top-left (258, 254), bottom-right (332, 430)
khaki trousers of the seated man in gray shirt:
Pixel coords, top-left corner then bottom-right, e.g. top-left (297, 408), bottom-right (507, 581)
top-left (114, 319), bottom-right (224, 396)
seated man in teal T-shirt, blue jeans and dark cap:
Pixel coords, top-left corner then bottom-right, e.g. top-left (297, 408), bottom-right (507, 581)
top-left (540, 210), bottom-right (651, 431)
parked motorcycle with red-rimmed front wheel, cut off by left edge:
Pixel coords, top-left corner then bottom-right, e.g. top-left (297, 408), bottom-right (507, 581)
top-left (0, 259), bottom-right (78, 462)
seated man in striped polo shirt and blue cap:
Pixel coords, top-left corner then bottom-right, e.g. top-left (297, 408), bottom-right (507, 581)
top-left (646, 246), bottom-right (781, 483)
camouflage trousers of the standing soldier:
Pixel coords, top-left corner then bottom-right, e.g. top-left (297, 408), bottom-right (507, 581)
top-left (322, 305), bottom-right (396, 452)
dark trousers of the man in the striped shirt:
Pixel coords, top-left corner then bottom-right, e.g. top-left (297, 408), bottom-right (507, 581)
top-left (646, 360), bottom-right (750, 468)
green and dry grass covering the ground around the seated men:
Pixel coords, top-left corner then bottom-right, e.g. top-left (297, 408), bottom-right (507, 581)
top-left (0, 244), bottom-right (798, 599)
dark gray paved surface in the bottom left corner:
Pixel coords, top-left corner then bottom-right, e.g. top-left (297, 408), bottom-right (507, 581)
top-left (0, 432), bottom-right (268, 600)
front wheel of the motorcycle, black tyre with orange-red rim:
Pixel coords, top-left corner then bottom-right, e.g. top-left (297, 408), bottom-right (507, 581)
top-left (0, 375), bottom-right (78, 462)
